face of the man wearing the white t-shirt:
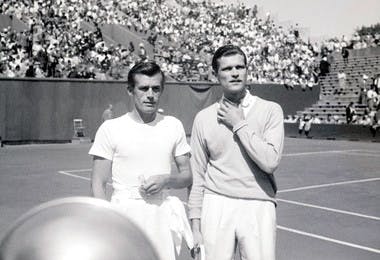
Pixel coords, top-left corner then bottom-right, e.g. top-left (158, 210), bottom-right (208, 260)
top-left (128, 73), bottom-right (163, 117)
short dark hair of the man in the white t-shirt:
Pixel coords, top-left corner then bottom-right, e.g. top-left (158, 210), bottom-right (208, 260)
top-left (128, 61), bottom-right (165, 89)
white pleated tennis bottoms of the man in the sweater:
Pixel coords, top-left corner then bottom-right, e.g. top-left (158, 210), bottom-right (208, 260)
top-left (201, 194), bottom-right (276, 260)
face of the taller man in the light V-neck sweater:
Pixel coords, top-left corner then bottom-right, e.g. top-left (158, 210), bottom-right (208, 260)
top-left (216, 54), bottom-right (247, 95)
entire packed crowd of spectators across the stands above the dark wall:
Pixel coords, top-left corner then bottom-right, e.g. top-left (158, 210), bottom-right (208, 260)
top-left (0, 0), bottom-right (378, 84)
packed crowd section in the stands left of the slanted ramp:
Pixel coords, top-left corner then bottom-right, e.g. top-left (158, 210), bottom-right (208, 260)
top-left (0, 0), bottom-right (137, 79)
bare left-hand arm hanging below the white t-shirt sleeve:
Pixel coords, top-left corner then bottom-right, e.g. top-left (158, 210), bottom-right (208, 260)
top-left (91, 156), bottom-right (112, 200)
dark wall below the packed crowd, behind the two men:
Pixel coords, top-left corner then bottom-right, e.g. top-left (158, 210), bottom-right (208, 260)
top-left (0, 78), bottom-right (319, 141)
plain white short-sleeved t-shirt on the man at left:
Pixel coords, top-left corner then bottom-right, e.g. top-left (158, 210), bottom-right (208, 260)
top-left (89, 113), bottom-right (190, 190)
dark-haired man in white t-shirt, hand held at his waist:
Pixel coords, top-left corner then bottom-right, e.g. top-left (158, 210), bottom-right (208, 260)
top-left (89, 62), bottom-right (192, 260)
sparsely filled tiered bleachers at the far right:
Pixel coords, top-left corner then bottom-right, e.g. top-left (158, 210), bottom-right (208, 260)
top-left (297, 48), bottom-right (380, 124)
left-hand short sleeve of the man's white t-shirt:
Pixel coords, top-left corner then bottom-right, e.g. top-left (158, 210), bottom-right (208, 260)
top-left (88, 121), bottom-right (114, 161)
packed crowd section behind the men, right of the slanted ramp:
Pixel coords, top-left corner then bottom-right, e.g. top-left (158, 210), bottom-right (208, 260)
top-left (119, 0), bottom-right (318, 87)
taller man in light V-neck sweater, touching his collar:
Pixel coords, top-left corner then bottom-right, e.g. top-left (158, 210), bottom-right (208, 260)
top-left (189, 45), bottom-right (284, 260)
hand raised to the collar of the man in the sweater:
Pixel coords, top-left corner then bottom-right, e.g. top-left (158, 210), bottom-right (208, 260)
top-left (218, 99), bottom-right (244, 129)
